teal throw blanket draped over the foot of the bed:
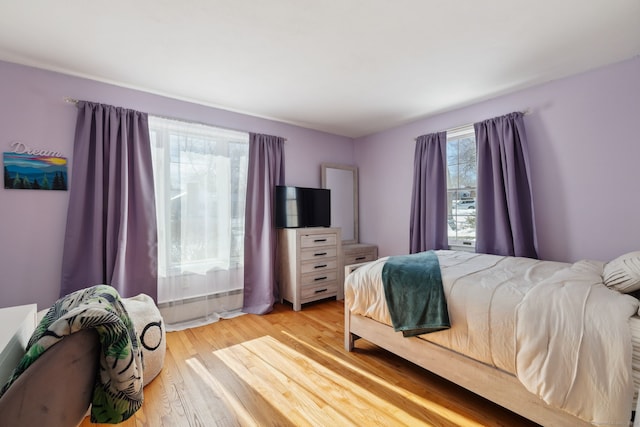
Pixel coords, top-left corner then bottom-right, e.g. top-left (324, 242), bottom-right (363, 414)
top-left (382, 251), bottom-right (451, 337)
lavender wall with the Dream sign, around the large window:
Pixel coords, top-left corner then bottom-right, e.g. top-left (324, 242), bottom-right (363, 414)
top-left (0, 61), bottom-right (354, 308)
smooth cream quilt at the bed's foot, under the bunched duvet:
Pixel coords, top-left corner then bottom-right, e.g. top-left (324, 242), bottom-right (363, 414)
top-left (345, 251), bottom-right (567, 374)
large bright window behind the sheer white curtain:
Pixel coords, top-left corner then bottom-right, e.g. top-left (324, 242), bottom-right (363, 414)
top-left (149, 116), bottom-right (249, 300)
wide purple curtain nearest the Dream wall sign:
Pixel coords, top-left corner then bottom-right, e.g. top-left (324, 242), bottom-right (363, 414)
top-left (60, 101), bottom-right (157, 300)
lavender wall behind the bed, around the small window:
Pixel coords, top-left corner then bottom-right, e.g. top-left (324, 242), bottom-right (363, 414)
top-left (355, 57), bottom-right (640, 261)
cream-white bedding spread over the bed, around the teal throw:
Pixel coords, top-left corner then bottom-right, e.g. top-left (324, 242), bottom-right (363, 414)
top-left (345, 251), bottom-right (638, 425)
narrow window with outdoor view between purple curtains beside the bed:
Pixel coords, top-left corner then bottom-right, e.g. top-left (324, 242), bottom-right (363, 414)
top-left (447, 125), bottom-right (478, 248)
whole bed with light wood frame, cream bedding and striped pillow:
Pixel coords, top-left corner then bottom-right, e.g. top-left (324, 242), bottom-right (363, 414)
top-left (345, 251), bottom-right (640, 426)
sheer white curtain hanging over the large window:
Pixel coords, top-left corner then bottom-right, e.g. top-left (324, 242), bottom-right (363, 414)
top-left (149, 116), bottom-right (249, 331)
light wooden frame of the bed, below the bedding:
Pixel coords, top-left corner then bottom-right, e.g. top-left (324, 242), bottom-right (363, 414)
top-left (344, 263), bottom-right (596, 427)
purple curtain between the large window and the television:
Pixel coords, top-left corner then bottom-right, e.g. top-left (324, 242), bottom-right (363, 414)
top-left (242, 133), bottom-right (285, 314)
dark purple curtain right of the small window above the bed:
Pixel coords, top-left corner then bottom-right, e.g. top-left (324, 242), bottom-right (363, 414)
top-left (474, 112), bottom-right (538, 258)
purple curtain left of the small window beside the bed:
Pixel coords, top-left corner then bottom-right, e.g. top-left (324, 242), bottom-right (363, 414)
top-left (409, 132), bottom-right (448, 253)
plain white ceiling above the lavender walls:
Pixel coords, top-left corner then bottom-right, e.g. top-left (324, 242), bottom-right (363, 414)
top-left (0, 0), bottom-right (640, 137)
